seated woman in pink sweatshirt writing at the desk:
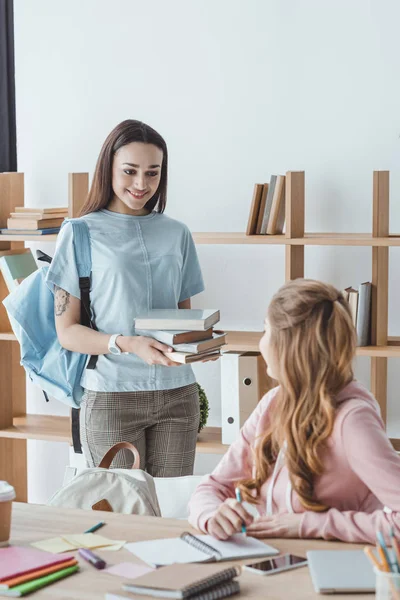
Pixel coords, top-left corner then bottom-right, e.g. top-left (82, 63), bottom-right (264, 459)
top-left (189, 279), bottom-right (400, 543)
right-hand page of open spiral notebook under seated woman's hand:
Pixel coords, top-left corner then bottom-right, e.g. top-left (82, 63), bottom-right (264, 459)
top-left (196, 533), bottom-right (279, 560)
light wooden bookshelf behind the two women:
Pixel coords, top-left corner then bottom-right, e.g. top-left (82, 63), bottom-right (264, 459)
top-left (0, 171), bottom-right (400, 501)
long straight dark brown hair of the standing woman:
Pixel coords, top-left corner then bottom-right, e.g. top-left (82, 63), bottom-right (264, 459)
top-left (80, 119), bottom-right (168, 217)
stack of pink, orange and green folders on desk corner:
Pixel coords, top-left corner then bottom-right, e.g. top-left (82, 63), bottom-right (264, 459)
top-left (0, 546), bottom-right (79, 598)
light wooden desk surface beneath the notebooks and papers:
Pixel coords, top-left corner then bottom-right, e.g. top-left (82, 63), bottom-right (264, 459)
top-left (10, 502), bottom-right (372, 600)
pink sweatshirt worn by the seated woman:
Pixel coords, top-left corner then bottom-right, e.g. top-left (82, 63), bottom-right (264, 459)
top-left (189, 381), bottom-right (400, 543)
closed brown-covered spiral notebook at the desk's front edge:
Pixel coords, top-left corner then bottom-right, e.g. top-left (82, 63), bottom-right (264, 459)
top-left (123, 564), bottom-right (241, 600)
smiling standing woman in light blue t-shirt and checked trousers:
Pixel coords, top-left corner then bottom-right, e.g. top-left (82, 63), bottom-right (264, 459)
top-left (47, 120), bottom-right (204, 477)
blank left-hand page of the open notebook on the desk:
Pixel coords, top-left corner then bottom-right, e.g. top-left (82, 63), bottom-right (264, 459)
top-left (125, 536), bottom-right (210, 566)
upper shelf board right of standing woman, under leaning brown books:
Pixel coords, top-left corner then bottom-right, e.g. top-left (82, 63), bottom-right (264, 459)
top-left (193, 232), bottom-right (400, 246)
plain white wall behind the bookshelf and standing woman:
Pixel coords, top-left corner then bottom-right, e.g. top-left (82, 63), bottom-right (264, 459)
top-left (14, 0), bottom-right (400, 501)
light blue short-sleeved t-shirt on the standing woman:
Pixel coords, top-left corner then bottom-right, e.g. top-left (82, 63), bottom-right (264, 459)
top-left (47, 210), bottom-right (204, 392)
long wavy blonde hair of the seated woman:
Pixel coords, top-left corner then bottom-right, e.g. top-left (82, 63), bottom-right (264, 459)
top-left (238, 279), bottom-right (356, 511)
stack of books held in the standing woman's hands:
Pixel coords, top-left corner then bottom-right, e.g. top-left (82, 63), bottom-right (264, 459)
top-left (135, 308), bottom-right (225, 364)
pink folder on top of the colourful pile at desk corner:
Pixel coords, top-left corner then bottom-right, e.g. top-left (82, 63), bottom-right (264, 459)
top-left (0, 546), bottom-right (74, 583)
